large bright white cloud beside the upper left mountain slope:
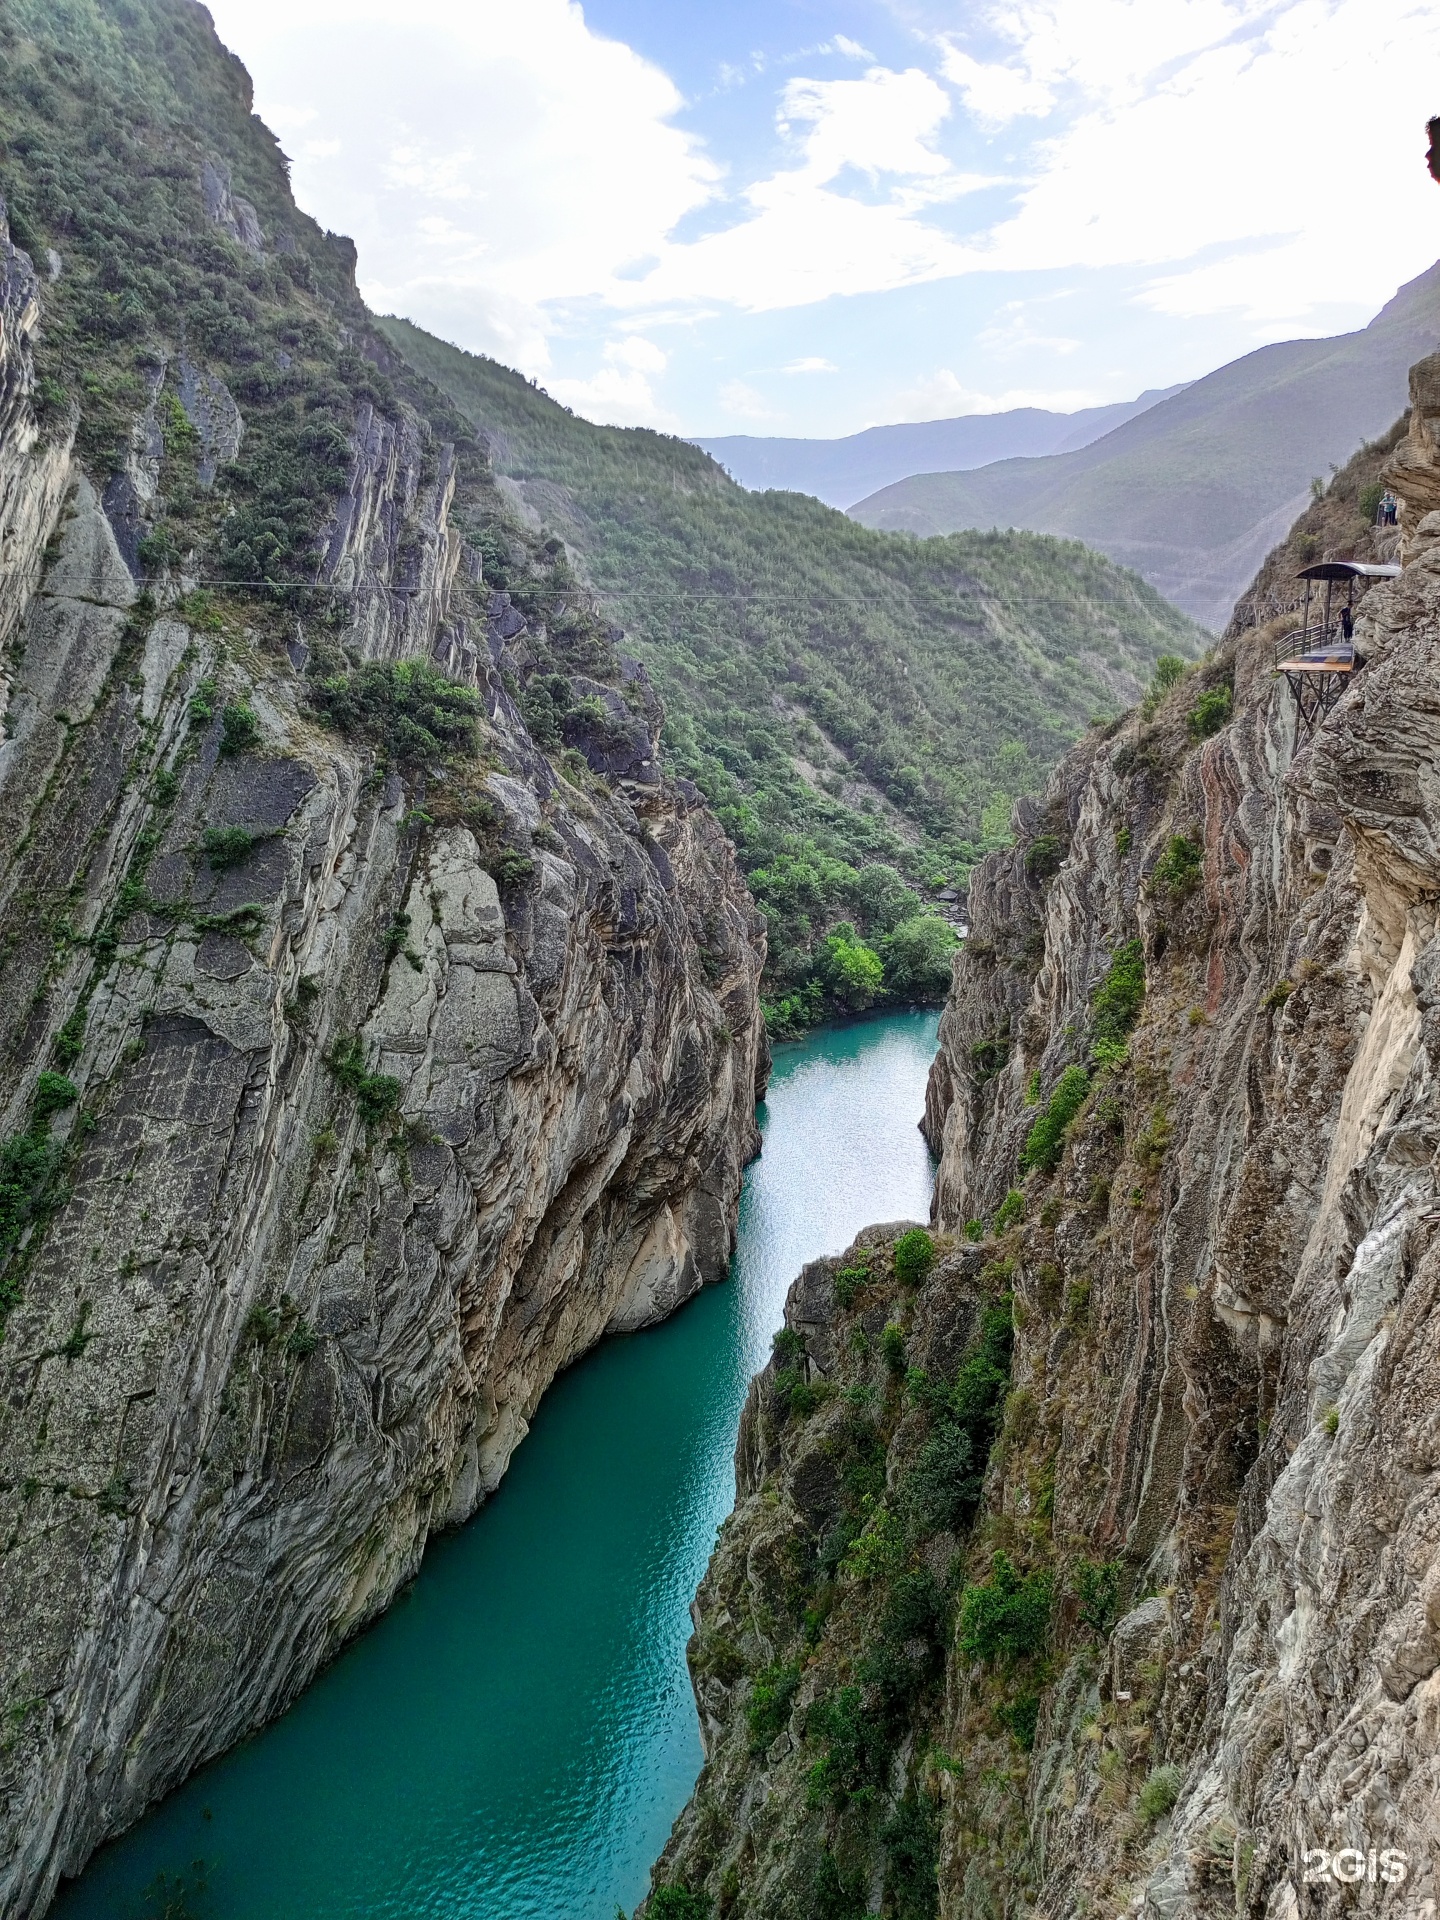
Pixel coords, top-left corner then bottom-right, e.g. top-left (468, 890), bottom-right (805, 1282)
top-left (211, 0), bottom-right (720, 372)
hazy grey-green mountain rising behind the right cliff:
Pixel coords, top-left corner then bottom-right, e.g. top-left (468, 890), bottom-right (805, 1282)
top-left (841, 263), bottom-right (1440, 632)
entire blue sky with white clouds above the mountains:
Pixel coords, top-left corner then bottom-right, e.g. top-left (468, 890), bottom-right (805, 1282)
top-left (211, 0), bottom-right (1440, 436)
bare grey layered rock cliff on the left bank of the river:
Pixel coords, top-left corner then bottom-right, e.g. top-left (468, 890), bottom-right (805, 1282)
top-left (0, 202), bottom-right (764, 1916)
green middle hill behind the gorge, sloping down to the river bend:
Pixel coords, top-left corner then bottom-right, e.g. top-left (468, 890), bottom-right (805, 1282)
top-left (380, 321), bottom-right (1200, 1006)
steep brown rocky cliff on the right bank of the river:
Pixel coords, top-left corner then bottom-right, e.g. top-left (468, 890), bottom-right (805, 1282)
top-left (651, 353), bottom-right (1440, 1920)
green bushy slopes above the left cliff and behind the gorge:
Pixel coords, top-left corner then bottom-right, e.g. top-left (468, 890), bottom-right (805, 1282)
top-left (0, 0), bottom-right (1200, 1031)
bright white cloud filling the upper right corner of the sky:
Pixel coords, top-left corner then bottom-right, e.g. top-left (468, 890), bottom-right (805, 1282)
top-left (948, 0), bottom-right (1440, 328)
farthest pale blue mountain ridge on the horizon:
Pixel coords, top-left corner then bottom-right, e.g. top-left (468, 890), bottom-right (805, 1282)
top-left (695, 386), bottom-right (1181, 507)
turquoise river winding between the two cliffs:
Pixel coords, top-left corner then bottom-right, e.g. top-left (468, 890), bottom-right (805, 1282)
top-left (52, 1012), bottom-right (937, 1920)
